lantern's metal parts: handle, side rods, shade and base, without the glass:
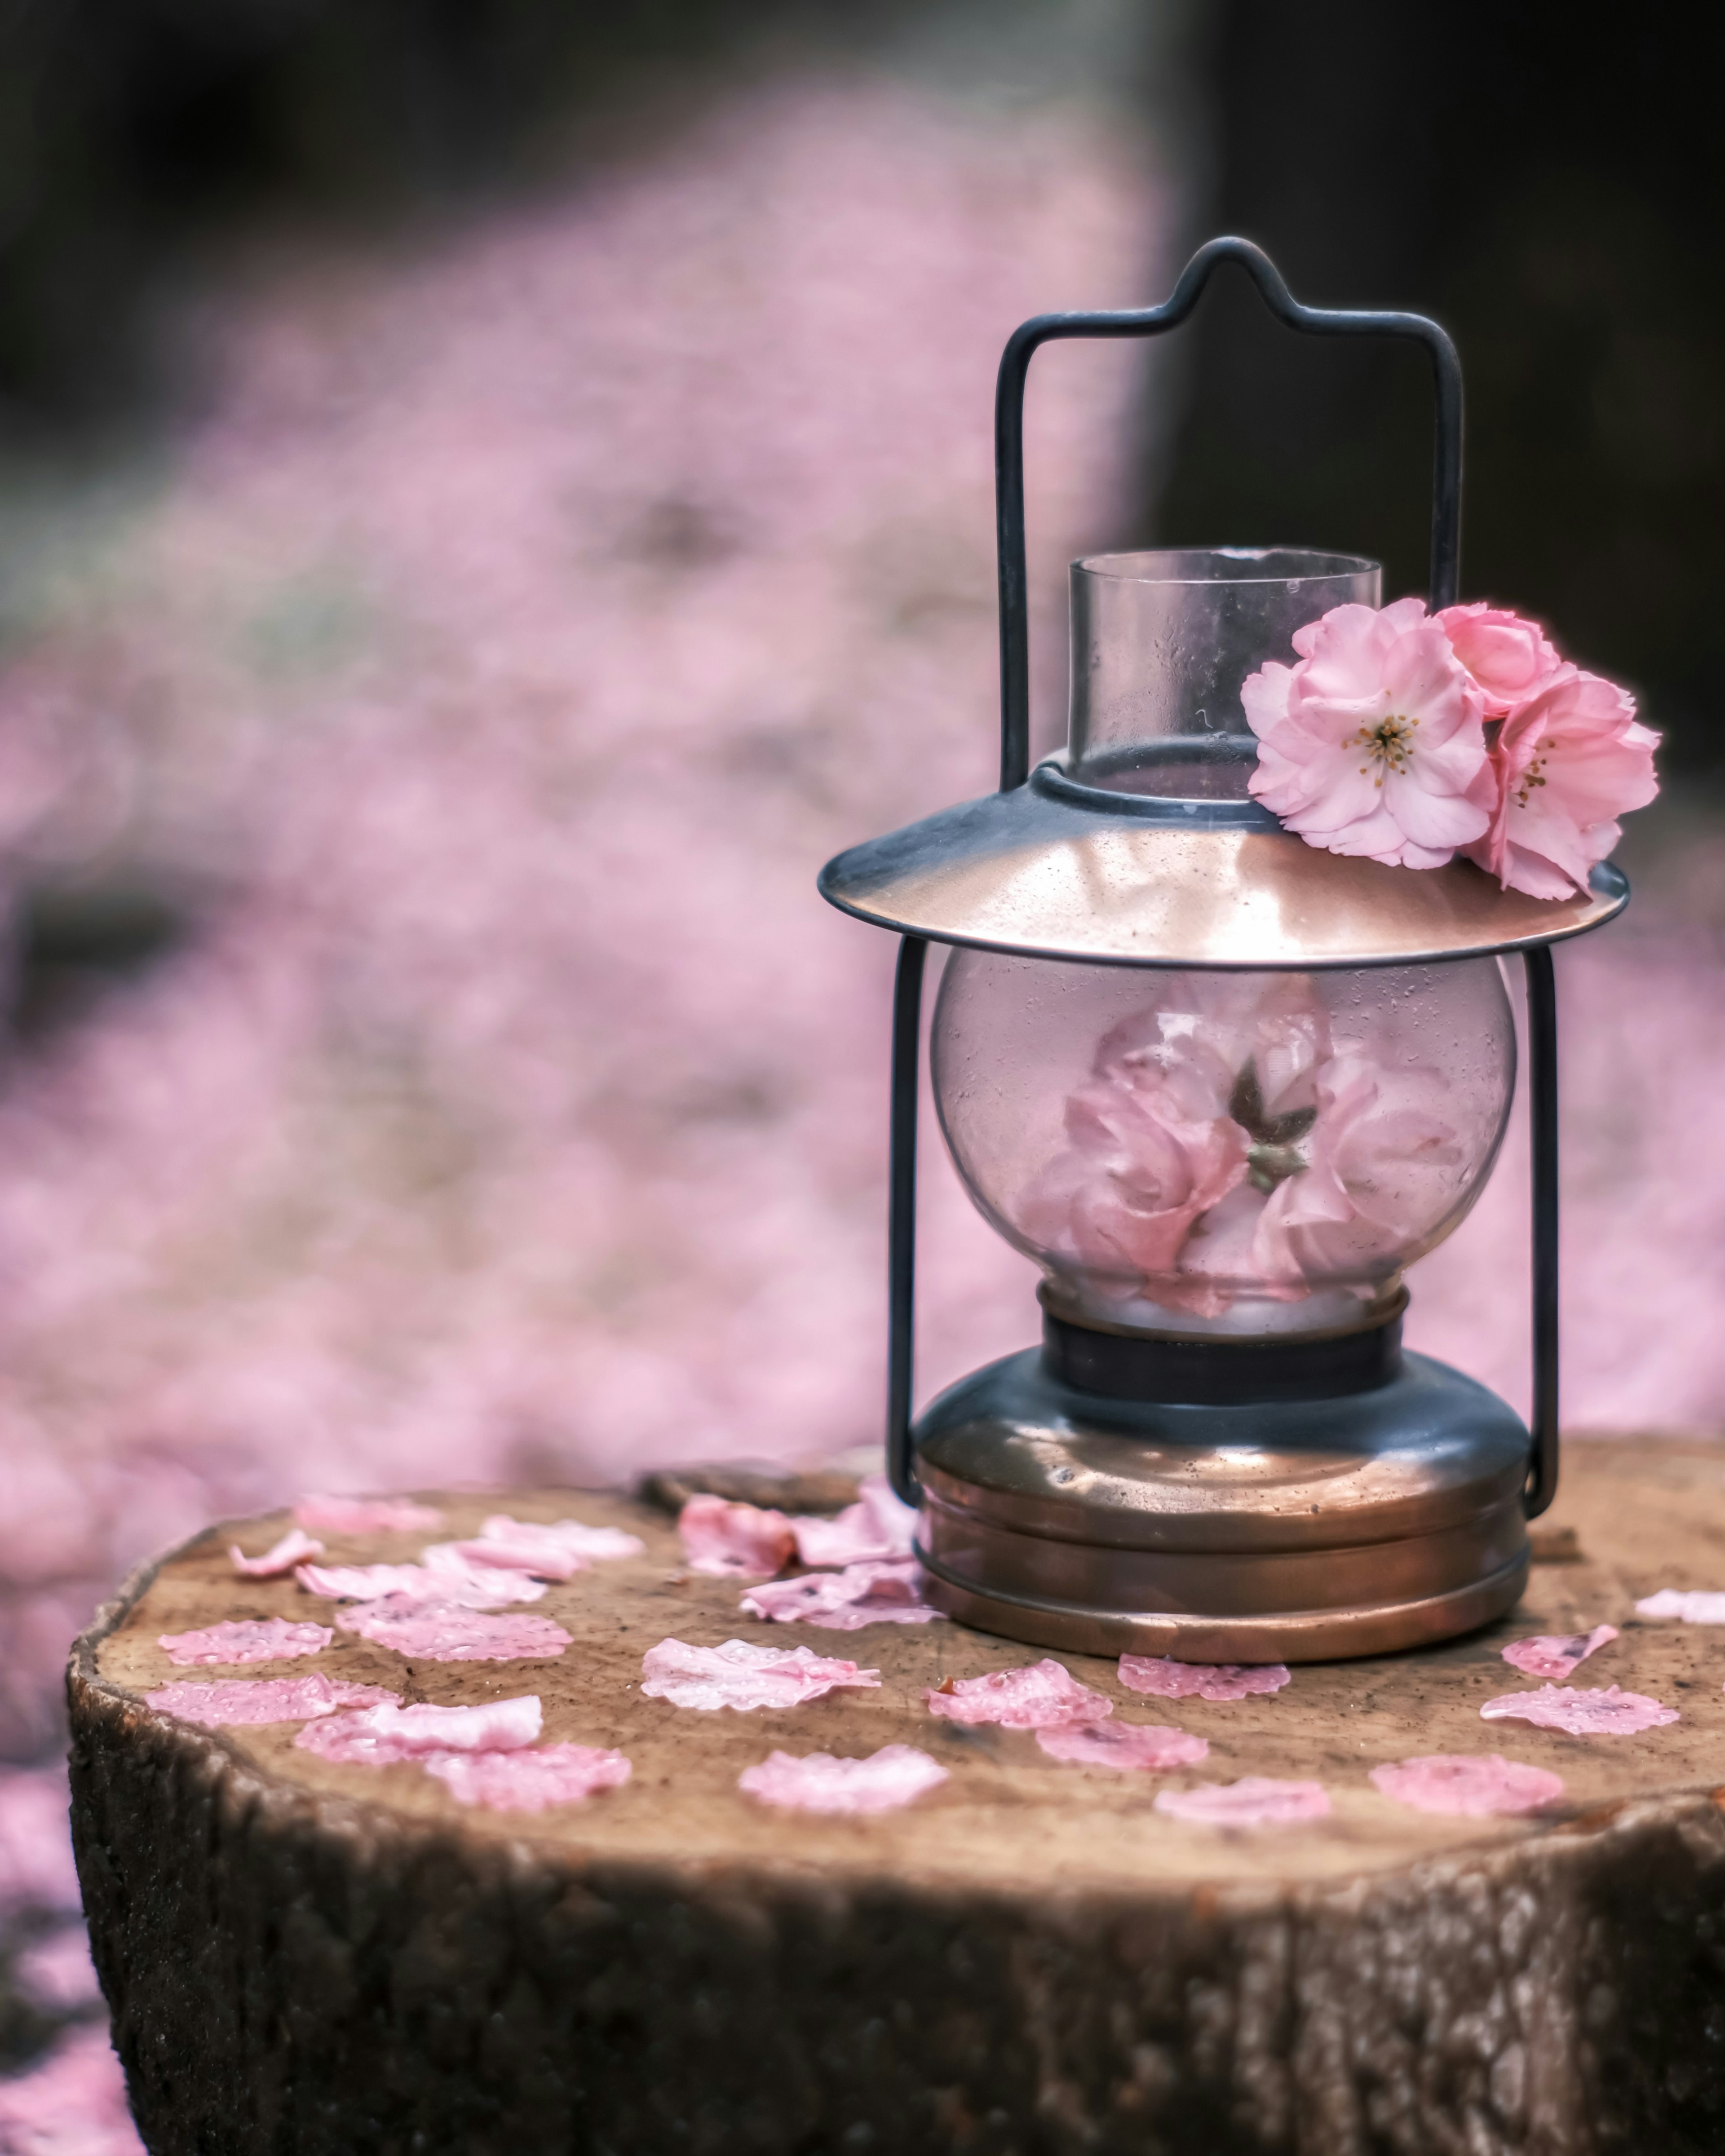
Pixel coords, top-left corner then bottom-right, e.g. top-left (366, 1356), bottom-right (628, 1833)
top-left (819, 239), bottom-right (1604, 1662)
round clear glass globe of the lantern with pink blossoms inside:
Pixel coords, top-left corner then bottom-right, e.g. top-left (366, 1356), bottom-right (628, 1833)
top-left (932, 951), bottom-right (1516, 1334)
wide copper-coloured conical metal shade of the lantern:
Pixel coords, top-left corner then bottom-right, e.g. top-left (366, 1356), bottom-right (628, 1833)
top-left (819, 765), bottom-right (1628, 968)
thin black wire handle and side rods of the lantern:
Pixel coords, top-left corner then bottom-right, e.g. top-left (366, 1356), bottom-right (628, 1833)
top-left (886, 237), bottom-right (1557, 1518)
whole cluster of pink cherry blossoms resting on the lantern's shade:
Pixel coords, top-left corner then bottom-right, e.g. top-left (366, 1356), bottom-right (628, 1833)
top-left (1240, 599), bottom-right (1658, 899)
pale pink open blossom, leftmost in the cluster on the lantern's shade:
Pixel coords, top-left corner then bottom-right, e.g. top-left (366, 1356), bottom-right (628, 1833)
top-left (1240, 599), bottom-right (1492, 869)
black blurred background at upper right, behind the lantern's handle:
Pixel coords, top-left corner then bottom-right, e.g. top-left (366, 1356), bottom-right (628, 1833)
top-left (1156, 0), bottom-right (1725, 776)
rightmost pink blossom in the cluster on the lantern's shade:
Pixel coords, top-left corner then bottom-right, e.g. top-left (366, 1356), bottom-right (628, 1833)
top-left (1464, 666), bottom-right (1658, 899)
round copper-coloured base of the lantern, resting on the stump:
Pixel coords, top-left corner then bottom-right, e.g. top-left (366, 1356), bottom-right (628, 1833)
top-left (916, 1348), bottom-right (1531, 1662)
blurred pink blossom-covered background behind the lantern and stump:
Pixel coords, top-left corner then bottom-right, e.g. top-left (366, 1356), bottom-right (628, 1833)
top-left (0, 50), bottom-right (1725, 2150)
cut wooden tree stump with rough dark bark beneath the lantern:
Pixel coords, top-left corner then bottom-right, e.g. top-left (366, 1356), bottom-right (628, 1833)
top-left (69, 1442), bottom-right (1725, 2156)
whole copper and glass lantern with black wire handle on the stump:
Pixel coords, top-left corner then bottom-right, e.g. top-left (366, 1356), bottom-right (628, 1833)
top-left (822, 239), bottom-right (1628, 1662)
